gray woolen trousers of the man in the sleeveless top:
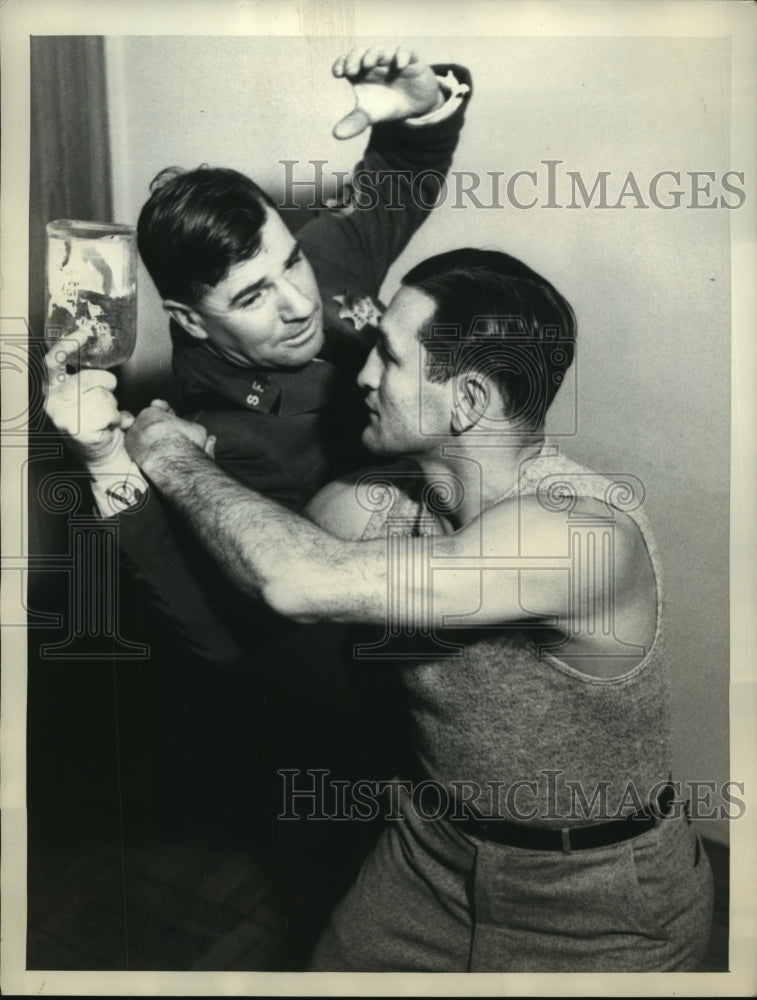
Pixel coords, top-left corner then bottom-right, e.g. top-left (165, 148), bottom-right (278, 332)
top-left (310, 795), bottom-right (712, 972)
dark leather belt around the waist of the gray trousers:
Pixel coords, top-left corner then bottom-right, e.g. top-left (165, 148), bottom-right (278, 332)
top-left (424, 785), bottom-right (675, 853)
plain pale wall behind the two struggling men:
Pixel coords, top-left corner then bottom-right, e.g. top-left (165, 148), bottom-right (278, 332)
top-left (106, 37), bottom-right (738, 839)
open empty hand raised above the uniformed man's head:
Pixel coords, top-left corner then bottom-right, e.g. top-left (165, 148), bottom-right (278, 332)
top-left (331, 46), bottom-right (443, 139)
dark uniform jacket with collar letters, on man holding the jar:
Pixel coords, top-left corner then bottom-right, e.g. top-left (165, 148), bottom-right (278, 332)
top-left (119, 66), bottom-right (470, 663)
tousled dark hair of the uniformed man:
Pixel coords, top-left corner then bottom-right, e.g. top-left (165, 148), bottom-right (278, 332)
top-left (137, 165), bottom-right (274, 305)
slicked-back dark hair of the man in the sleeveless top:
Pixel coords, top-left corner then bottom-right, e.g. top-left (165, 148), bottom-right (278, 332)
top-left (402, 247), bottom-right (576, 431)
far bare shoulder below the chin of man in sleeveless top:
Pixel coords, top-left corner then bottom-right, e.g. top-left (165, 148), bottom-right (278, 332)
top-left (304, 461), bottom-right (420, 540)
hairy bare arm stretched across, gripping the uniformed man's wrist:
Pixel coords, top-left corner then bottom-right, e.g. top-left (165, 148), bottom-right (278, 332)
top-left (127, 402), bottom-right (634, 627)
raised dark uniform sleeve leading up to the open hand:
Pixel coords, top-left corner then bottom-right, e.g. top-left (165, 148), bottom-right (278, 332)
top-left (298, 66), bottom-right (471, 305)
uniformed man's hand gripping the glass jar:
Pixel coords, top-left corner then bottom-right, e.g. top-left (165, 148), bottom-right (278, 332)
top-left (45, 331), bottom-right (134, 469)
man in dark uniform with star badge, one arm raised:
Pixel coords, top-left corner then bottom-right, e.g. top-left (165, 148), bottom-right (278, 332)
top-left (48, 49), bottom-right (470, 960)
